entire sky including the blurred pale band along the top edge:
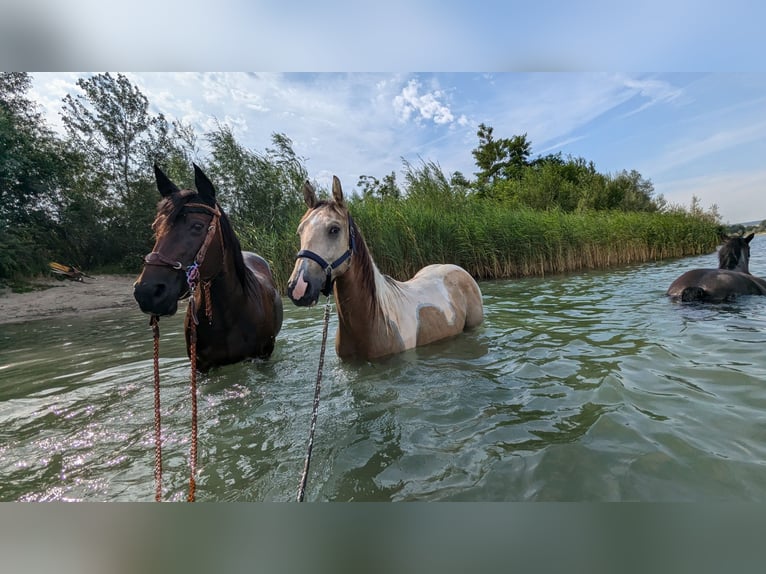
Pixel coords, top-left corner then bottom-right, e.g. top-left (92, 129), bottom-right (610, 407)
top-left (6, 0), bottom-right (766, 223)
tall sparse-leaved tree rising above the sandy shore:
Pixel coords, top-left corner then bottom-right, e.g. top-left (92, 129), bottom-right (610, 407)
top-left (61, 73), bottom-right (179, 268)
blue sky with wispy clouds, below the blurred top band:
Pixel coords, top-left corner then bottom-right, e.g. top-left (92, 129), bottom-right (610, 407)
top-left (32, 72), bottom-right (766, 223)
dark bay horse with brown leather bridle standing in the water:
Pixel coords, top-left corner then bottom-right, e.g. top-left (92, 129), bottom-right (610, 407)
top-left (133, 165), bottom-right (282, 372)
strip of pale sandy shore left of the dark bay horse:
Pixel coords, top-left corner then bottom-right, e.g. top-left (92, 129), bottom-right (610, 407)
top-left (0, 275), bottom-right (139, 324)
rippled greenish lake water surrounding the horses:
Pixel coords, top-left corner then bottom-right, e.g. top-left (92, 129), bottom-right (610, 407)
top-left (0, 236), bottom-right (766, 501)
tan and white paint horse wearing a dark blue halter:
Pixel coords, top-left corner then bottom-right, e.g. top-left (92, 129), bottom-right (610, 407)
top-left (287, 177), bottom-right (484, 360)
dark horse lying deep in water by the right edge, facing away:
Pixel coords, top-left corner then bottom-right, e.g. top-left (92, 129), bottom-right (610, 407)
top-left (667, 233), bottom-right (766, 303)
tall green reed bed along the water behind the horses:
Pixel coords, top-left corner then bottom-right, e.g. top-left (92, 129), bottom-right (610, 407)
top-left (241, 198), bottom-right (720, 289)
